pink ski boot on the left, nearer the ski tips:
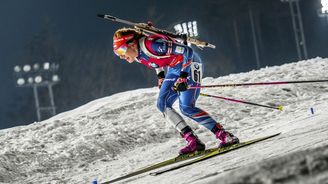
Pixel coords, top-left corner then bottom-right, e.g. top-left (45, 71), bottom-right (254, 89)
top-left (179, 128), bottom-right (205, 155)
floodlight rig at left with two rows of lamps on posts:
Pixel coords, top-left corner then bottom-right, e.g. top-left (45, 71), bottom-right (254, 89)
top-left (14, 62), bottom-right (60, 121)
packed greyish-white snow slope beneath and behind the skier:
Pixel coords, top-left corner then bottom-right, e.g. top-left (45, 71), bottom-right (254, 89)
top-left (0, 58), bottom-right (328, 184)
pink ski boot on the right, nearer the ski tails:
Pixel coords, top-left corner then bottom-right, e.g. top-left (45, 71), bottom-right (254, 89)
top-left (212, 124), bottom-right (239, 148)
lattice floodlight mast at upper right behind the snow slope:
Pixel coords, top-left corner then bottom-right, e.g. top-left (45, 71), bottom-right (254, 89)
top-left (281, 0), bottom-right (308, 60)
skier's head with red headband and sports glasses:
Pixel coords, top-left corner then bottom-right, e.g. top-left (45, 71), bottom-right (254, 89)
top-left (113, 28), bottom-right (142, 63)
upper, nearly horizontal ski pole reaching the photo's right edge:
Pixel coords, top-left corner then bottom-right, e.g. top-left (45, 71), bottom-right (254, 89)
top-left (189, 80), bottom-right (328, 89)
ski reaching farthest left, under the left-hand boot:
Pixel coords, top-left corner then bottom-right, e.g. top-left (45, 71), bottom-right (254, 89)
top-left (102, 148), bottom-right (218, 184)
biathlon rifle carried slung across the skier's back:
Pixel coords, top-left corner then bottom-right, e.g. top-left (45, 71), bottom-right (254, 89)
top-left (97, 14), bottom-right (215, 49)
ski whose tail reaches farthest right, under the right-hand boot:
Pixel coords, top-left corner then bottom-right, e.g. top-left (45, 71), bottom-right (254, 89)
top-left (150, 133), bottom-right (280, 176)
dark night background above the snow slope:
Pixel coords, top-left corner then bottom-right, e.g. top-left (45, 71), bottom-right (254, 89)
top-left (0, 0), bottom-right (328, 129)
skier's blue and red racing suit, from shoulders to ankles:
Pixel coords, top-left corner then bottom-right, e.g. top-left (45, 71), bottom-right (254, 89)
top-left (137, 35), bottom-right (217, 132)
